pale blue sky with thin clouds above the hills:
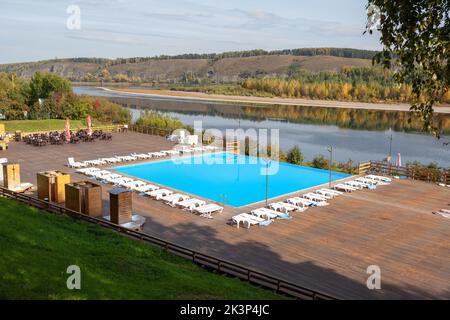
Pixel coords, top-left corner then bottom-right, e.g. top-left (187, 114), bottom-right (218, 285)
top-left (0, 0), bottom-right (381, 63)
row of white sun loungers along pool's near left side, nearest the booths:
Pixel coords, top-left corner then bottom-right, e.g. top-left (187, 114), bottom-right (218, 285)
top-left (77, 168), bottom-right (223, 218)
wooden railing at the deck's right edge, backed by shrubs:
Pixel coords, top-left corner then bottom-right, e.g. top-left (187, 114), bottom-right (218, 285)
top-left (360, 161), bottom-right (450, 184)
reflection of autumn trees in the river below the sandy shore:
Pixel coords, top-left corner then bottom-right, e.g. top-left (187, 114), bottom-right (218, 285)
top-left (113, 98), bottom-right (450, 134)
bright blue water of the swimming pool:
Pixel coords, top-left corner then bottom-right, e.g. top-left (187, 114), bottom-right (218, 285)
top-left (114, 153), bottom-right (350, 207)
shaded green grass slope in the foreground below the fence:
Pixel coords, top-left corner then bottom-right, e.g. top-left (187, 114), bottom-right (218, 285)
top-left (0, 198), bottom-right (283, 299)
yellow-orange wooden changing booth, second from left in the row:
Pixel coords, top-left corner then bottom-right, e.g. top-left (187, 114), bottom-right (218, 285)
top-left (37, 171), bottom-right (70, 203)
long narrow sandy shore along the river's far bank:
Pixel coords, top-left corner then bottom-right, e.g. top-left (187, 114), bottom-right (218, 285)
top-left (100, 87), bottom-right (450, 114)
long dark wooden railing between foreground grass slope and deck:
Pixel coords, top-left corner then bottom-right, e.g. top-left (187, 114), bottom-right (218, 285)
top-left (0, 187), bottom-right (336, 300)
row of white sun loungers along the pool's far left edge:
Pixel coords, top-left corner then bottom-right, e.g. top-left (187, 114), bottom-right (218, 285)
top-left (67, 146), bottom-right (218, 169)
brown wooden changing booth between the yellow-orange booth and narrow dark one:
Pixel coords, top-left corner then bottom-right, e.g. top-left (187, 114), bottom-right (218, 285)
top-left (65, 181), bottom-right (103, 217)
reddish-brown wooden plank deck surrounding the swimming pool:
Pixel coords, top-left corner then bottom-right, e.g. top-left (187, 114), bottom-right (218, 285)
top-left (0, 133), bottom-right (450, 299)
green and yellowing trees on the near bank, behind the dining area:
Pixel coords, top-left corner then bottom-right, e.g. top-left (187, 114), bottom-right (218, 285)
top-left (0, 72), bottom-right (131, 123)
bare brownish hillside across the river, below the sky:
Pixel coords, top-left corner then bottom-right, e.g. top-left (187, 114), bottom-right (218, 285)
top-left (0, 49), bottom-right (371, 82)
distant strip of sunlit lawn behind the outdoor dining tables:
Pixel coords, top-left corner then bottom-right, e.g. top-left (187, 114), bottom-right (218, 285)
top-left (0, 119), bottom-right (109, 132)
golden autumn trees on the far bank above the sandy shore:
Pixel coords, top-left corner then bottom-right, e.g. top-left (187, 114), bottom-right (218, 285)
top-left (241, 65), bottom-right (450, 103)
